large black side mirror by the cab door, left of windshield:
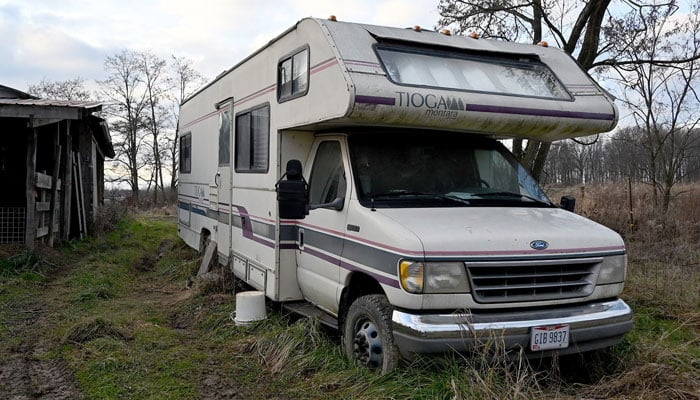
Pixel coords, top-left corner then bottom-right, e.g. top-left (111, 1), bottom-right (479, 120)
top-left (275, 160), bottom-right (309, 219)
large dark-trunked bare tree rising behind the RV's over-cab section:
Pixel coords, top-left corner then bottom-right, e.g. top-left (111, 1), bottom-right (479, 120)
top-left (438, 0), bottom-right (698, 185)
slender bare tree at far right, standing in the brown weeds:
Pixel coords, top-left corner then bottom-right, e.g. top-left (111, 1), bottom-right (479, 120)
top-left (607, 1), bottom-right (700, 214)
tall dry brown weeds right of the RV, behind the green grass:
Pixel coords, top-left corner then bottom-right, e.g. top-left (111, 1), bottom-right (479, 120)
top-left (550, 184), bottom-right (700, 320)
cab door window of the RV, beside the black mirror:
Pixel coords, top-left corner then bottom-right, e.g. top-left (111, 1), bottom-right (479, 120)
top-left (309, 141), bottom-right (347, 204)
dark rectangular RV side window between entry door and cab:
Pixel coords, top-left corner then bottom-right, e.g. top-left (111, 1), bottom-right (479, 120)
top-left (236, 105), bottom-right (270, 172)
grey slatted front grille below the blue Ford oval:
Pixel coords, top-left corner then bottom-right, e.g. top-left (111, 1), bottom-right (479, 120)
top-left (465, 258), bottom-right (602, 303)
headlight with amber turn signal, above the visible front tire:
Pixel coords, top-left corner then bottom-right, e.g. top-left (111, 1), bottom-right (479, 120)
top-left (399, 261), bottom-right (469, 293)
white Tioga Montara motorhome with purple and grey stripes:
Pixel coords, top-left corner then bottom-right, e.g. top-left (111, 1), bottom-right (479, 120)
top-left (178, 18), bottom-right (632, 371)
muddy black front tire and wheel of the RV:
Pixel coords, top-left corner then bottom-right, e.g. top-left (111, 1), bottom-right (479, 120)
top-left (343, 294), bottom-right (400, 374)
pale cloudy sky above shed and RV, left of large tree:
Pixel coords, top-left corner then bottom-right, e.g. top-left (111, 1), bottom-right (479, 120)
top-left (0, 0), bottom-right (439, 91)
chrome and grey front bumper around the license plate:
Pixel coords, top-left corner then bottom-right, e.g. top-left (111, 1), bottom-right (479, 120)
top-left (392, 299), bottom-right (632, 358)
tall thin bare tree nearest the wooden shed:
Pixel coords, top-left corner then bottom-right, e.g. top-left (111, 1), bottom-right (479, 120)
top-left (98, 50), bottom-right (148, 200)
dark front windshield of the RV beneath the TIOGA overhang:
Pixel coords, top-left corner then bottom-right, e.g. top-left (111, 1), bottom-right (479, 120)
top-left (349, 134), bottom-right (553, 207)
